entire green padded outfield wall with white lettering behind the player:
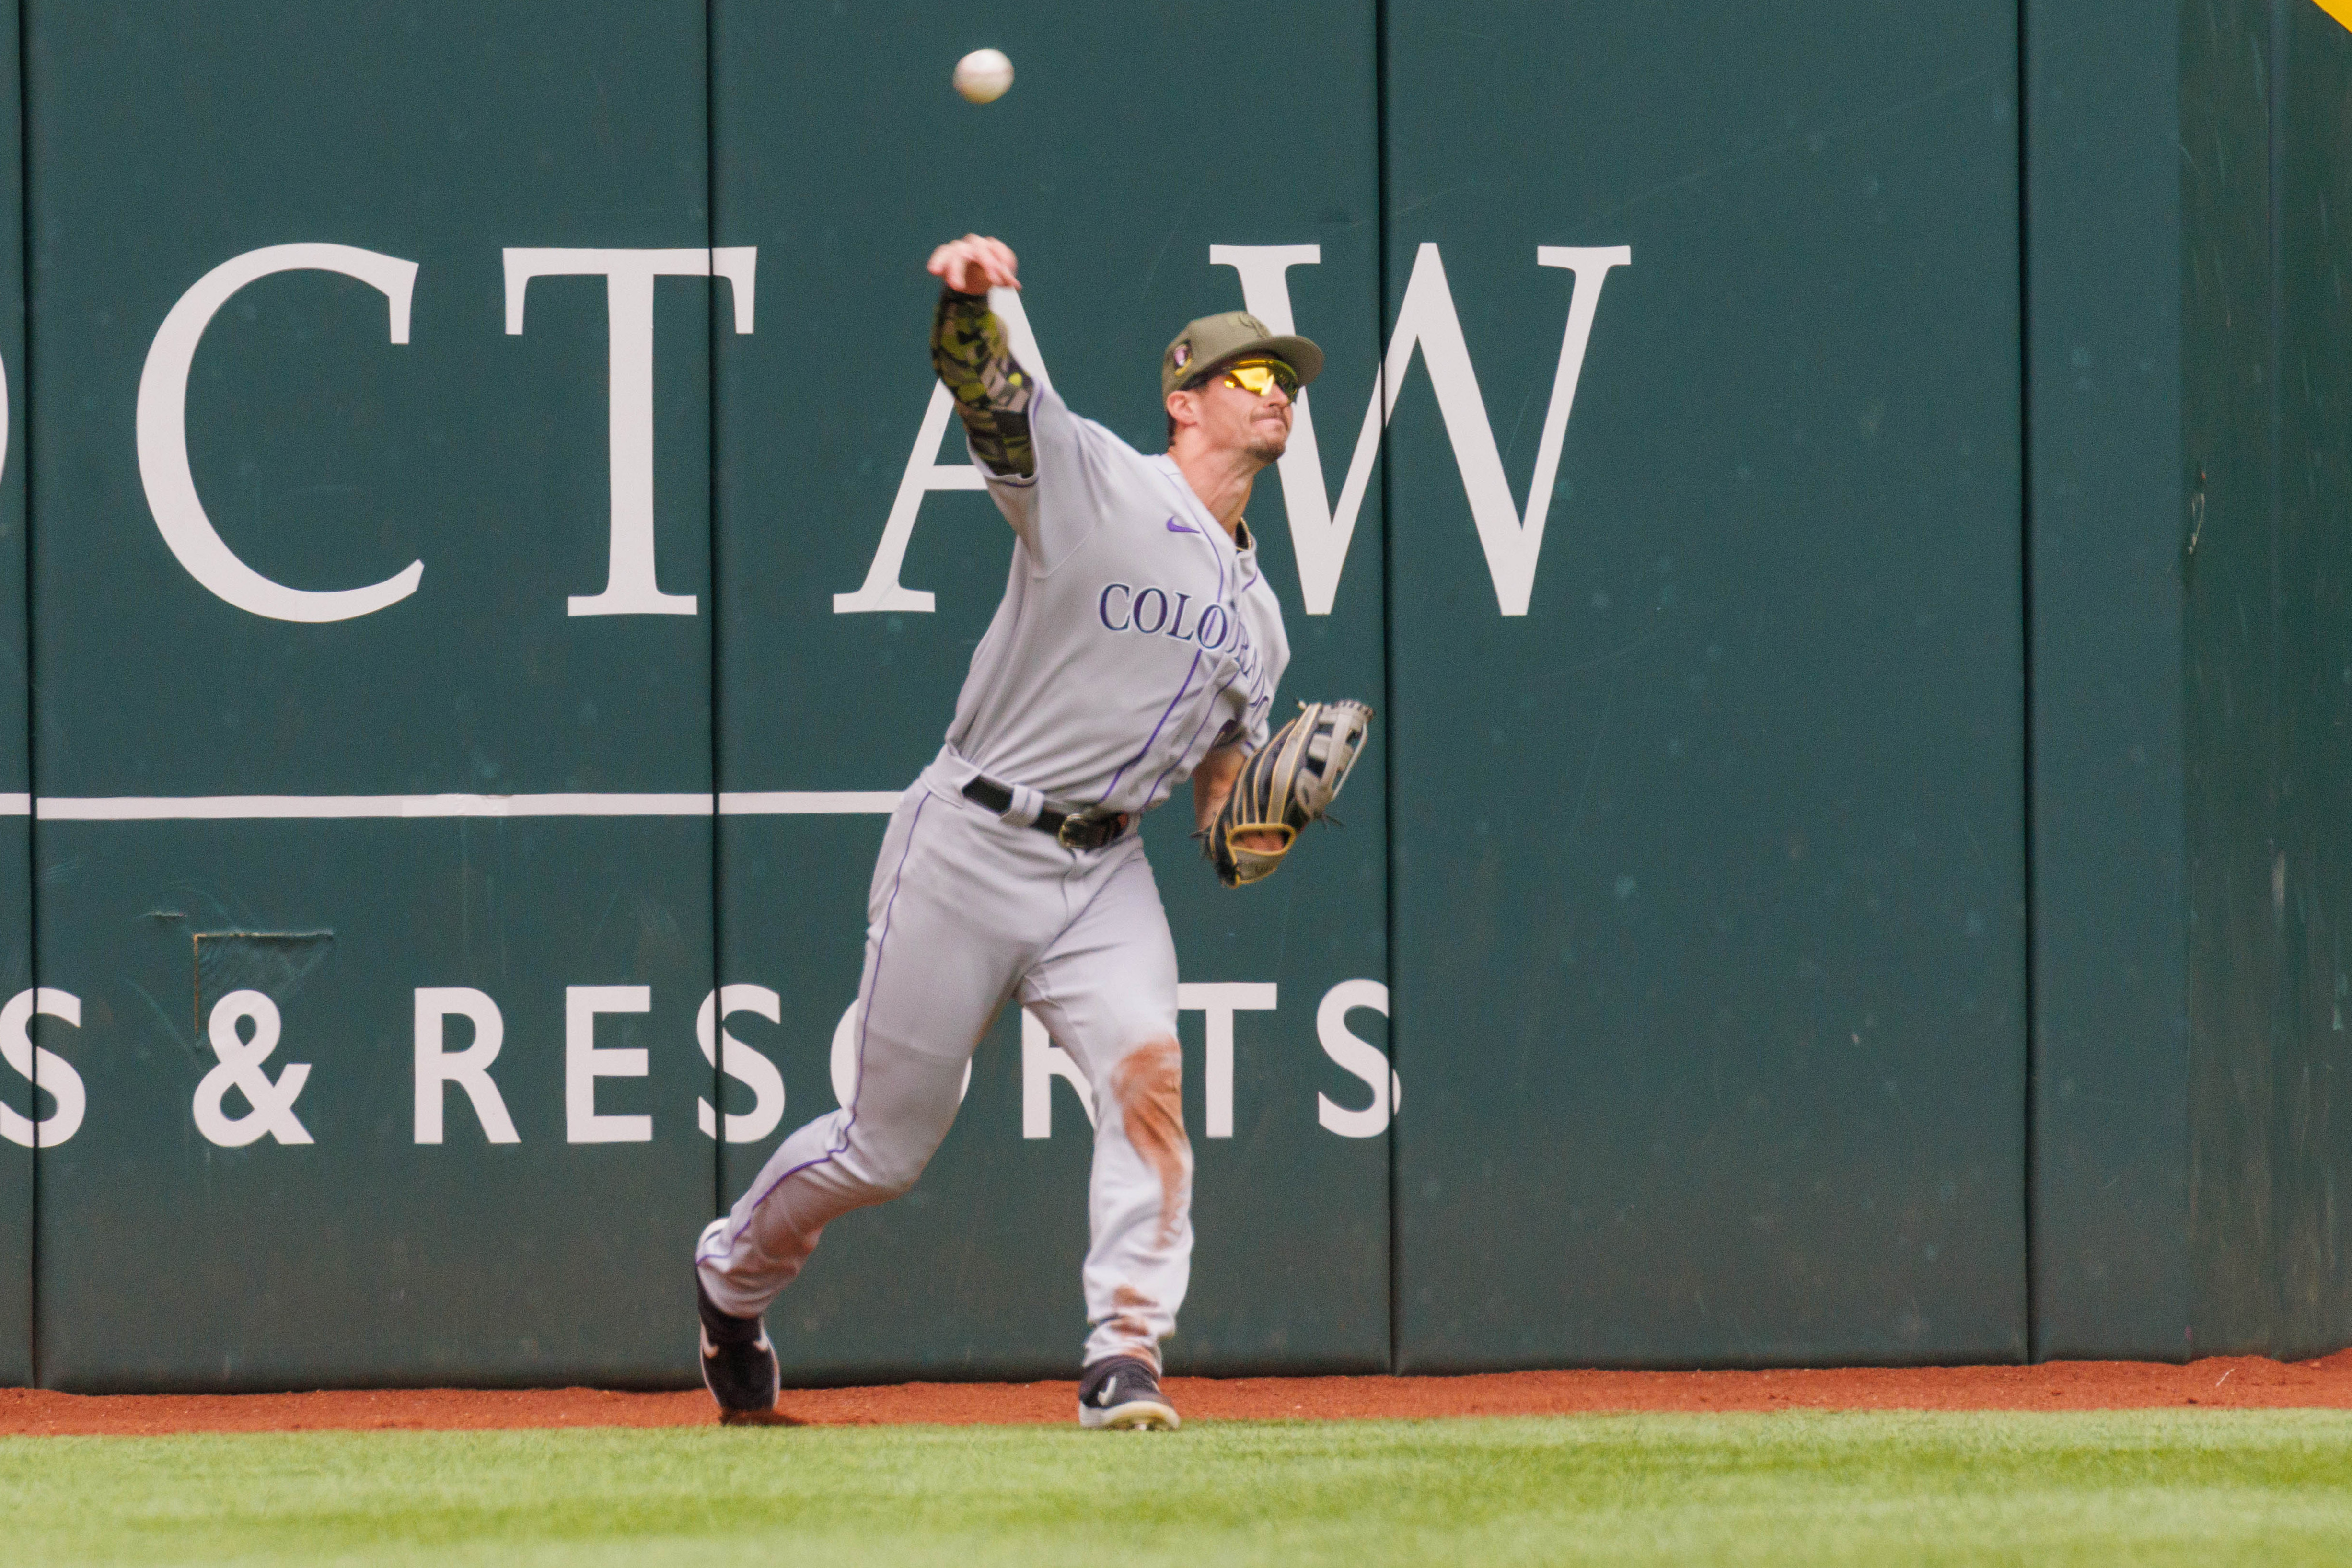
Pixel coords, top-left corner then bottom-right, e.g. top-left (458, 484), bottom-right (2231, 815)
top-left (0, 0), bottom-right (2352, 1392)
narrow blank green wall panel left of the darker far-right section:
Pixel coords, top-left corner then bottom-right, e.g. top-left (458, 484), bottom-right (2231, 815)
top-left (2023, 0), bottom-right (2192, 1359)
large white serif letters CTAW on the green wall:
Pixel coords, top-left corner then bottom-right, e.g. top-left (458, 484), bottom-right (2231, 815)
top-left (119, 244), bottom-right (1632, 623)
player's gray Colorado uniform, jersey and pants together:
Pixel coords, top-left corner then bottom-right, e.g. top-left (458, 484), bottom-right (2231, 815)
top-left (696, 343), bottom-right (1289, 1366)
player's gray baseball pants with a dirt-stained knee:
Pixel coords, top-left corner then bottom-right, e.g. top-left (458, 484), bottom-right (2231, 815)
top-left (694, 752), bottom-right (1193, 1366)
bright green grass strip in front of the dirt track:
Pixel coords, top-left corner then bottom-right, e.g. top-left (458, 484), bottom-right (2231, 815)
top-left (0, 1410), bottom-right (2352, 1568)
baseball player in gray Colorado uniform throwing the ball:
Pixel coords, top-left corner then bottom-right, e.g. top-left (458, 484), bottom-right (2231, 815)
top-left (694, 235), bottom-right (1371, 1429)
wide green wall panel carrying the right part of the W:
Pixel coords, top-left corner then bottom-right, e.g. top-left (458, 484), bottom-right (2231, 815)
top-left (1388, 5), bottom-right (2028, 1371)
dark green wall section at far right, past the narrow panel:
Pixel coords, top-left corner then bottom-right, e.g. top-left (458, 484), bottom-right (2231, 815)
top-left (2183, 5), bottom-right (2352, 1357)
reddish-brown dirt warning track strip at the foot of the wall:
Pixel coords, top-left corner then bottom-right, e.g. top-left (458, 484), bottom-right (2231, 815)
top-left (13, 1349), bottom-right (2352, 1436)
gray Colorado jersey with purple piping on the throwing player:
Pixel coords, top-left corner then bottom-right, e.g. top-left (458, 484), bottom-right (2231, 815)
top-left (948, 385), bottom-right (1291, 811)
